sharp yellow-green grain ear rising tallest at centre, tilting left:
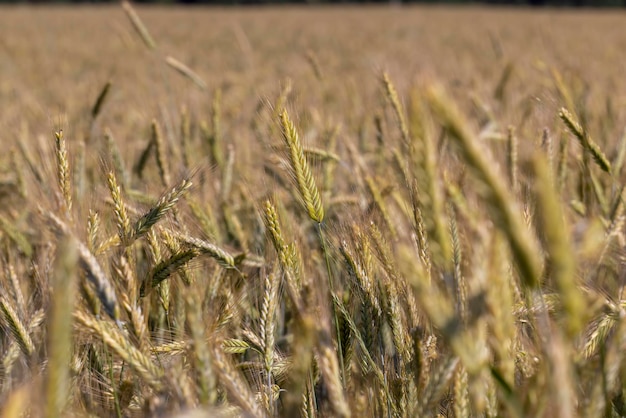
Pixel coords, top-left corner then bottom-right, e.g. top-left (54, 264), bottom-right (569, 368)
top-left (280, 110), bottom-right (324, 223)
